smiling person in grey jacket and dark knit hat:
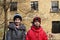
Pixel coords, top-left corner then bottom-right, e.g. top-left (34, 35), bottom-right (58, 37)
top-left (6, 14), bottom-right (26, 40)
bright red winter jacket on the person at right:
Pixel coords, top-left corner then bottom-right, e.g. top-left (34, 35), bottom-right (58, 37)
top-left (26, 26), bottom-right (48, 40)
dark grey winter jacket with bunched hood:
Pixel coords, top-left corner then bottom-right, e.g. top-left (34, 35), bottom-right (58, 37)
top-left (6, 23), bottom-right (26, 40)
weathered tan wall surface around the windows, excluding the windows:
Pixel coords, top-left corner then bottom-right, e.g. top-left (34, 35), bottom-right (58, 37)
top-left (0, 0), bottom-right (60, 39)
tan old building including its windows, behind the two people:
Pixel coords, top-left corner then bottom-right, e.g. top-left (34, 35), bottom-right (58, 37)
top-left (0, 0), bottom-right (60, 40)
